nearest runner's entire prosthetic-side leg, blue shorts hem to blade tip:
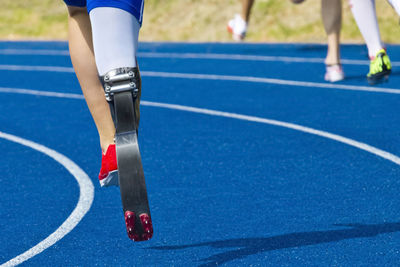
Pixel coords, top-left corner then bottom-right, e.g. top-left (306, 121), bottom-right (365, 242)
top-left (88, 0), bottom-right (153, 241)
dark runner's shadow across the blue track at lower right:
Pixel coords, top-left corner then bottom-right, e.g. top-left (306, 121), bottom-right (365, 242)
top-left (149, 222), bottom-right (400, 266)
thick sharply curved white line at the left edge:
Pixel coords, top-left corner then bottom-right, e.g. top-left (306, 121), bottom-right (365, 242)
top-left (0, 132), bottom-right (94, 267)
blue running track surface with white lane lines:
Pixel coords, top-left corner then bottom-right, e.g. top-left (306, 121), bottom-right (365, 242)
top-left (0, 41), bottom-right (400, 267)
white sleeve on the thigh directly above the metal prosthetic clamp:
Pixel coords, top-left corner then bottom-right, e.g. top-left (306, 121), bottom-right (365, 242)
top-left (89, 7), bottom-right (140, 75)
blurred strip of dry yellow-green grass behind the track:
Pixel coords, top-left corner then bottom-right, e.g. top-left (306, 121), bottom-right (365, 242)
top-left (0, 0), bottom-right (400, 43)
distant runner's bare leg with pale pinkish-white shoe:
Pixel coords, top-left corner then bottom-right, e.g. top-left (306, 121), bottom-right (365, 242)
top-left (321, 0), bottom-right (344, 82)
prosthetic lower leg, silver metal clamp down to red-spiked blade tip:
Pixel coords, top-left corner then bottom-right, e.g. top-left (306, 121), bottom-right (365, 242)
top-left (101, 68), bottom-right (153, 241)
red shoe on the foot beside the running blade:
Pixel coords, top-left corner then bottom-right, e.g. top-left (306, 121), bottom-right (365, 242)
top-left (99, 144), bottom-right (119, 187)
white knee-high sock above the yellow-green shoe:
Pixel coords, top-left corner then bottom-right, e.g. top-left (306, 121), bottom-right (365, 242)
top-left (349, 0), bottom-right (384, 57)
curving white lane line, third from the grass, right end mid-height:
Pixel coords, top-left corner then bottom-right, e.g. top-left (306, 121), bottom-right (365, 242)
top-left (0, 89), bottom-right (400, 170)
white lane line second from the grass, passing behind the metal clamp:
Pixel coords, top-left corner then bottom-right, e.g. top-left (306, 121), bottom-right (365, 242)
top-left (0, 65), bottom-right (400, 94)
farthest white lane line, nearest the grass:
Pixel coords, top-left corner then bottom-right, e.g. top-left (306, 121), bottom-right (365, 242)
top-left (0, 49), bottom-right (400, 66)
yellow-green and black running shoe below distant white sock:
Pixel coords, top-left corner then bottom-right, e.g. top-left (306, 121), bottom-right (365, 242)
top-left (367, 49), bottom-right (392, 85)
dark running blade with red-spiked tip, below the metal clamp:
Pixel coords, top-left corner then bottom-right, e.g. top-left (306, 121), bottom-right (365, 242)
top-left (114, 92), bottom-right (153, 241)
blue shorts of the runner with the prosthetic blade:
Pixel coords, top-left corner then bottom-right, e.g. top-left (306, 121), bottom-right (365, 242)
top-left (64, 0), bottom-right (144, 25)
